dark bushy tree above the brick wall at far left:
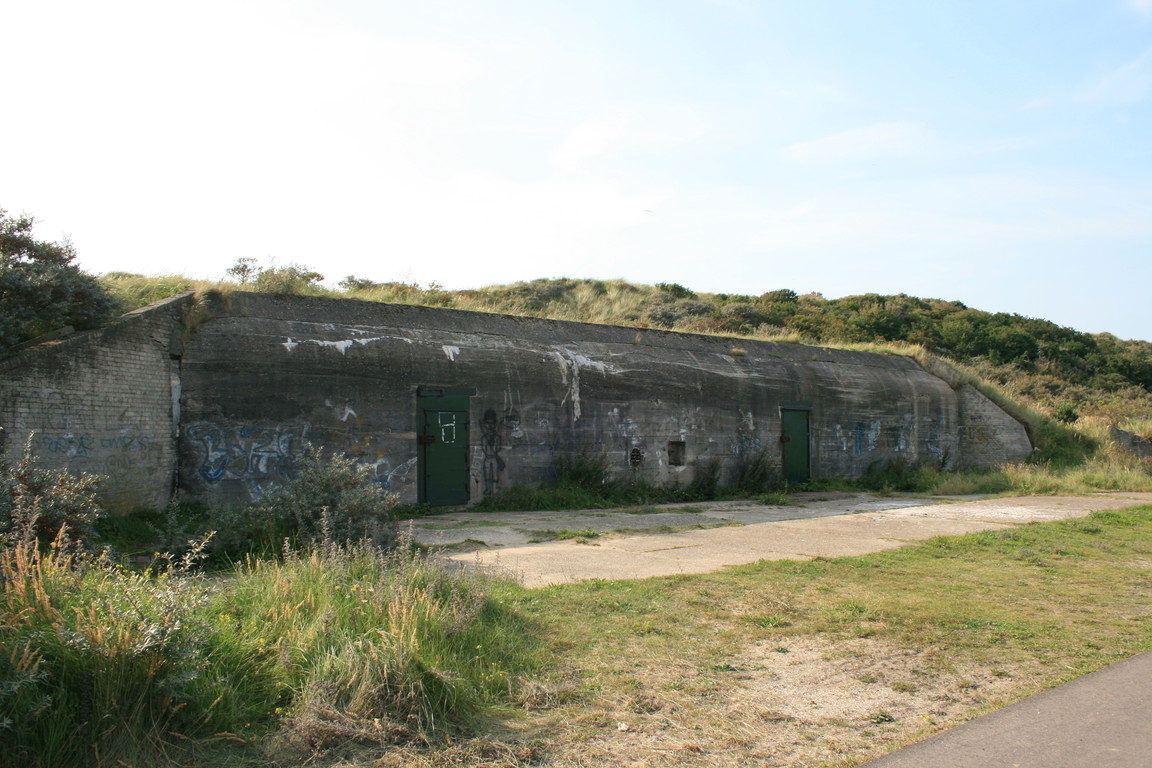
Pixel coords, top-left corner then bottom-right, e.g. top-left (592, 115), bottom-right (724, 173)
top-left (0, 208), bottom-right (121, 355)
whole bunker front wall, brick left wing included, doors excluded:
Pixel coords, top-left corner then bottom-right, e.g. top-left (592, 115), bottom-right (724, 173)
top-left (0, 292), bottom-right (1031, 509)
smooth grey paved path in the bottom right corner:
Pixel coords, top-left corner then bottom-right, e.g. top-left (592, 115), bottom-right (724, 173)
top-left (864, 653), bottom-right (1152, 768)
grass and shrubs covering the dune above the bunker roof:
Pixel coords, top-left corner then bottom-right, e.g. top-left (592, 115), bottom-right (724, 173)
top-left (96, 269), bottom-right (1152, 433)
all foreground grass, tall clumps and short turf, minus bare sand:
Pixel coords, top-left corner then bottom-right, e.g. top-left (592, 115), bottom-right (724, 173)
top-left (9, 495), bottom-right (1152, 767)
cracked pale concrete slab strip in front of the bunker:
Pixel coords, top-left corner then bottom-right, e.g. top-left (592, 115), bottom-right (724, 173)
top-left (423, 493), bottom-right (1152, 587)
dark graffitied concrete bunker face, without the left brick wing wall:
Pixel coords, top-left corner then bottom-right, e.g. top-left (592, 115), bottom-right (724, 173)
top-left (180, 294), bottom-right (1031, 503)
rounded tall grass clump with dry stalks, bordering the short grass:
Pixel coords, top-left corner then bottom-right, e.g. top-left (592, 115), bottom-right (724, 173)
top-left (235, 534), bottom-right (539, 750)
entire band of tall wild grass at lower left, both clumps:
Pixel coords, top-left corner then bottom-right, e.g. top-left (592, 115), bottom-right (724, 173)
top-left (0, 531), bottom-right (536, 768)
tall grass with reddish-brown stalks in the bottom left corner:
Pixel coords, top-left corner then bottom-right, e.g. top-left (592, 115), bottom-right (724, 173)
top-left (0, 540), bottom-right (220, 767)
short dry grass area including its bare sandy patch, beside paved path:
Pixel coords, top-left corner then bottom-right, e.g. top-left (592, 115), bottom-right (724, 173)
top-left (357, 508), bottom-right (1152, 768)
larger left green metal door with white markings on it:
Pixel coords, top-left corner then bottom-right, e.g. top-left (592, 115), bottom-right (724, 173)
top-left (418, 389), bottom-right (470, 507)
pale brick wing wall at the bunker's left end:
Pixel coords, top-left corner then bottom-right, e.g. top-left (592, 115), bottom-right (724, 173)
top-left (0, 296), bottom-right (190, 511)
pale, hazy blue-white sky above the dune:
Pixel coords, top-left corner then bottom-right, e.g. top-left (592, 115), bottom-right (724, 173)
top-left (0, 0), bottom-right (1152, 340)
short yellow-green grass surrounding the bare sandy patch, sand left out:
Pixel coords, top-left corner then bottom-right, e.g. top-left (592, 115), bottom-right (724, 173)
top-left (472, 507), bottom-right (1152, 766)
